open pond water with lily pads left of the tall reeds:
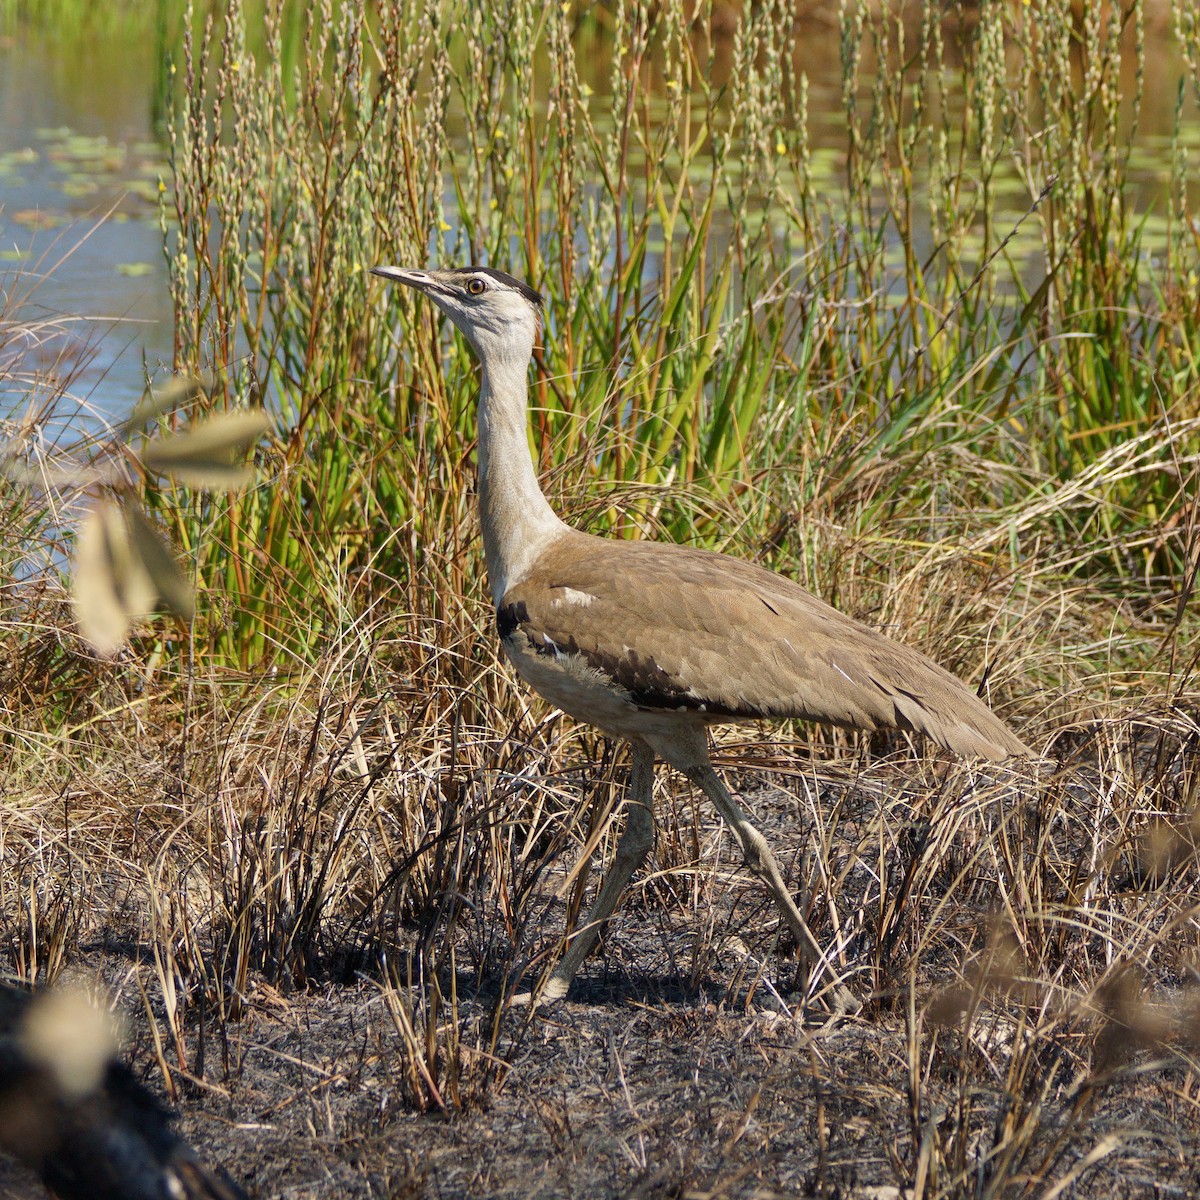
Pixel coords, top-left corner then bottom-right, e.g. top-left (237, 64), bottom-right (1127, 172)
top-left (0, 21), bottom-right (173, 429)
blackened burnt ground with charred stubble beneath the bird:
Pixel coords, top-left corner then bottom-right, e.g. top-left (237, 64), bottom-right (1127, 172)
top-left (0, 768), bottom-right (1200, 1200)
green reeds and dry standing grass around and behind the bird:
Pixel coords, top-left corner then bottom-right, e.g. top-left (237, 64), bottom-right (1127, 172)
top-left (0, 0), bottom-right (1200, 1196)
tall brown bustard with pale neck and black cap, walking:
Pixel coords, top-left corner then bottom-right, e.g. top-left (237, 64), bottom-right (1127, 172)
top-left (372, 265), bottom-right (1032, 1012)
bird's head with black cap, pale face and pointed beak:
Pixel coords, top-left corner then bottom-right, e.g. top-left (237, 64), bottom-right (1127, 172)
top-left (371, 266), bottom-right (542, 366)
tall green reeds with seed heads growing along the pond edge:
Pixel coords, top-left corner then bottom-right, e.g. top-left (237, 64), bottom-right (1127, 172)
top-left (150, 0), bottom-right (1198, 665)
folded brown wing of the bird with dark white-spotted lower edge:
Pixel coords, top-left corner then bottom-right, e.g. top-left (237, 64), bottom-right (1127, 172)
top-left (497, 534), bottom-right (1032, 758)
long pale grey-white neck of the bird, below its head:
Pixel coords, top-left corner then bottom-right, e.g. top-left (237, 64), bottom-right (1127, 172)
top-left (479, 355), bottom-right (566, 604)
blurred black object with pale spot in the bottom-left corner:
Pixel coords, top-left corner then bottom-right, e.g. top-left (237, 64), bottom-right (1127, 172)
top-left (0, 983), bottom-right (246, 1200)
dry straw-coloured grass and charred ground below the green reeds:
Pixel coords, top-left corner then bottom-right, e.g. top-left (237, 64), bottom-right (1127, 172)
top-left (0, 546), bottom-right (1200, 1196)
